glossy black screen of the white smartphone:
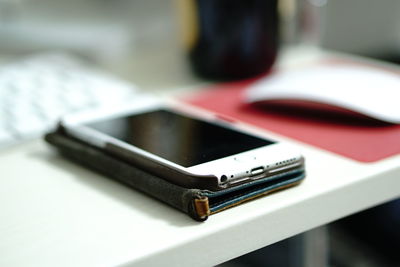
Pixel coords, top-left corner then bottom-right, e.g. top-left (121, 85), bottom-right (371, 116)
top-left (86, 109), bottom-right (274, 167)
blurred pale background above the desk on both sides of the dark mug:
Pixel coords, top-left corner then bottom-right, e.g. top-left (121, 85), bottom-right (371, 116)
top-left (0, 0), bottom-right (400, 87)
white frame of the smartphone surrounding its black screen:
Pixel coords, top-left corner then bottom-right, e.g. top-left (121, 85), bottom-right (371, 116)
top-left (60, 99), bottom-right (304, 191)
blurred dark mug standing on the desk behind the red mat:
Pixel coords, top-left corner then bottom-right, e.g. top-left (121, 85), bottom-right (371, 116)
top-left (180, 0), bottom-right (279, 80)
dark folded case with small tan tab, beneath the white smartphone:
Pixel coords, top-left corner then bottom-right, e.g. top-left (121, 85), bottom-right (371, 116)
top-left (45, 127), bottom-right (305, 221)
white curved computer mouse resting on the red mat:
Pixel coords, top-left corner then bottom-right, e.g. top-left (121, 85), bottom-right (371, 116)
top-left (245, 64), bottom-right (400, 124)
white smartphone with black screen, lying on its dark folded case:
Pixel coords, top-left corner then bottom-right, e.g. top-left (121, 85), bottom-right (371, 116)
top-left (61, 102), bottom-right (304, 191)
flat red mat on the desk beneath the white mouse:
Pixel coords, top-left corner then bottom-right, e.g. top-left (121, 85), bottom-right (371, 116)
top-left (184, 80), bottom-right (400, 162)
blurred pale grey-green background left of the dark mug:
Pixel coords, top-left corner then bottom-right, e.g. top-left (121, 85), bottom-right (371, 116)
top-left (0, 0), bottom-right (186, 90)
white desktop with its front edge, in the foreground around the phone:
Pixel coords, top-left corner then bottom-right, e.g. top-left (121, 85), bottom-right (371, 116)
top-left (0, 46), bottom-right (400, 266)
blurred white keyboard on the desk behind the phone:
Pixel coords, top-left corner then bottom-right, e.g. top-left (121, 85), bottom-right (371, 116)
top-left (0, 54), bottom-right (139, 149)
